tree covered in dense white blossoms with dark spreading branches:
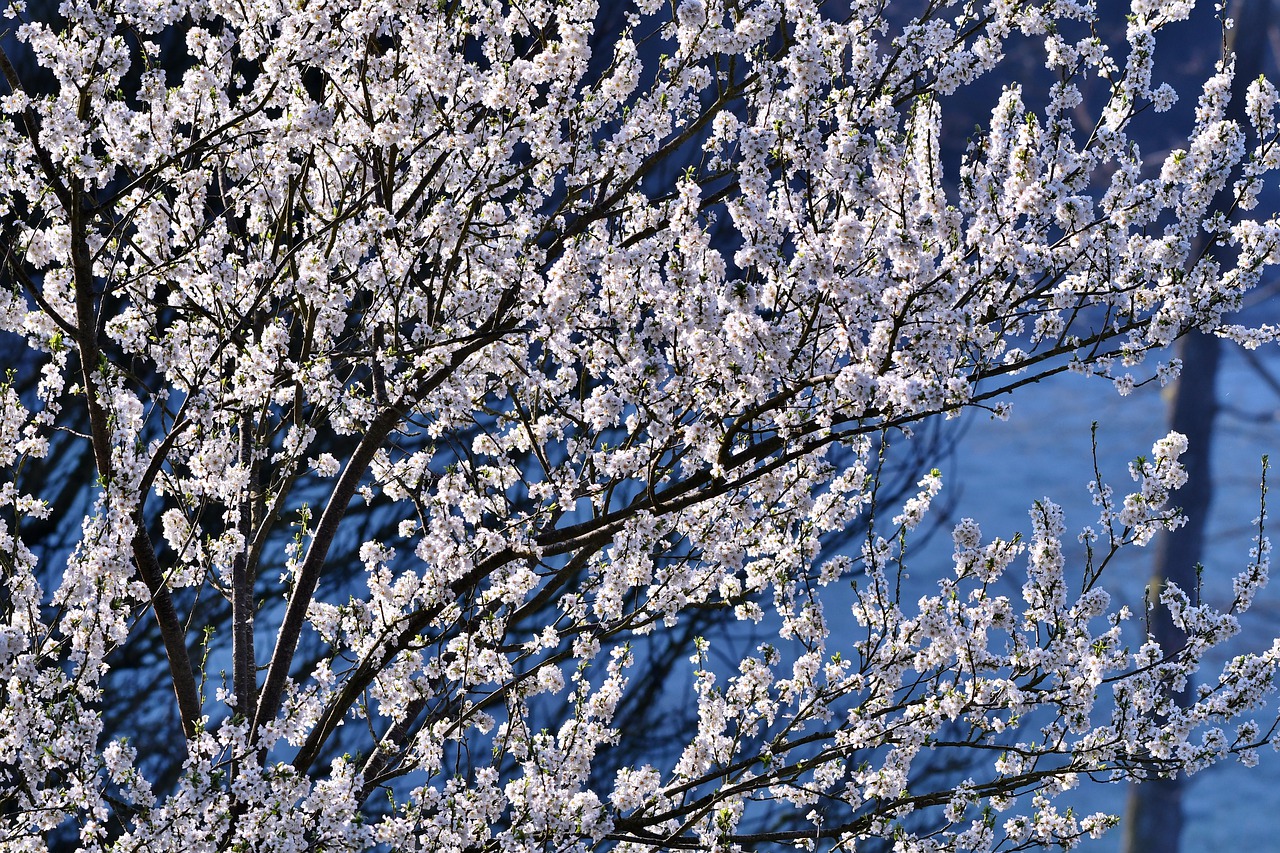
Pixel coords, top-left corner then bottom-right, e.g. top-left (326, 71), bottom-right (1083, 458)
top-left (0, 0), bottom-right (1280, 850)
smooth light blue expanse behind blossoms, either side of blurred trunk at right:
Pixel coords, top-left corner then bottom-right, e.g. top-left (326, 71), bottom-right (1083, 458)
top-left (932, 347), bottom-right (1280, 853)
